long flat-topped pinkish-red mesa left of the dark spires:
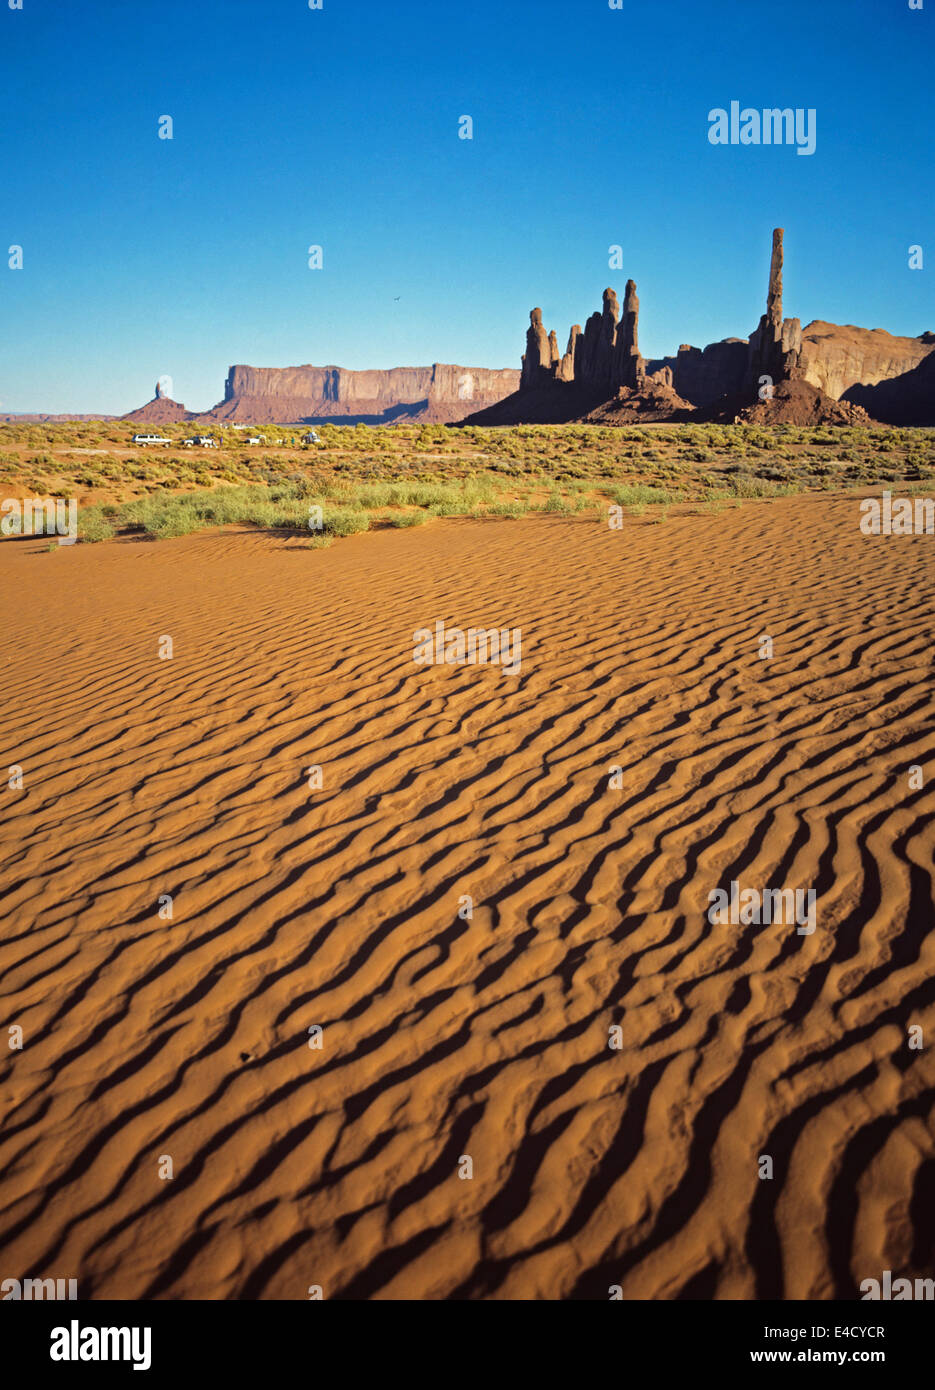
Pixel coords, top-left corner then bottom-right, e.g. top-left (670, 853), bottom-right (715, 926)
top-left (210, 363), bottom-right (520, 423)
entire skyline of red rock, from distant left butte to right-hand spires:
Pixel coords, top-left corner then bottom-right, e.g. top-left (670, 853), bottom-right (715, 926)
top-left (16, 227), bottom-right (935, 425)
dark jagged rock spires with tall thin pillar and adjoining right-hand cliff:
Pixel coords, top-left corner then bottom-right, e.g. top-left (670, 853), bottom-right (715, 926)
top-left (464, 227), bottom-right (935, 425)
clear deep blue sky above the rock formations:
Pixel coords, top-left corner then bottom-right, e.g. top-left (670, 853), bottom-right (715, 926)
top-left (0, 0), bottom-right (935, 413)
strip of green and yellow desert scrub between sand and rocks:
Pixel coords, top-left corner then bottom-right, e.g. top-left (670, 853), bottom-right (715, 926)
top-left (0, 420), bottom-right (935, 546)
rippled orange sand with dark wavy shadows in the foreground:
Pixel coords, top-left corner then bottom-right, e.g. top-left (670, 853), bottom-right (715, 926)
top-left (0, 496), bottom-right (935, 1300)
